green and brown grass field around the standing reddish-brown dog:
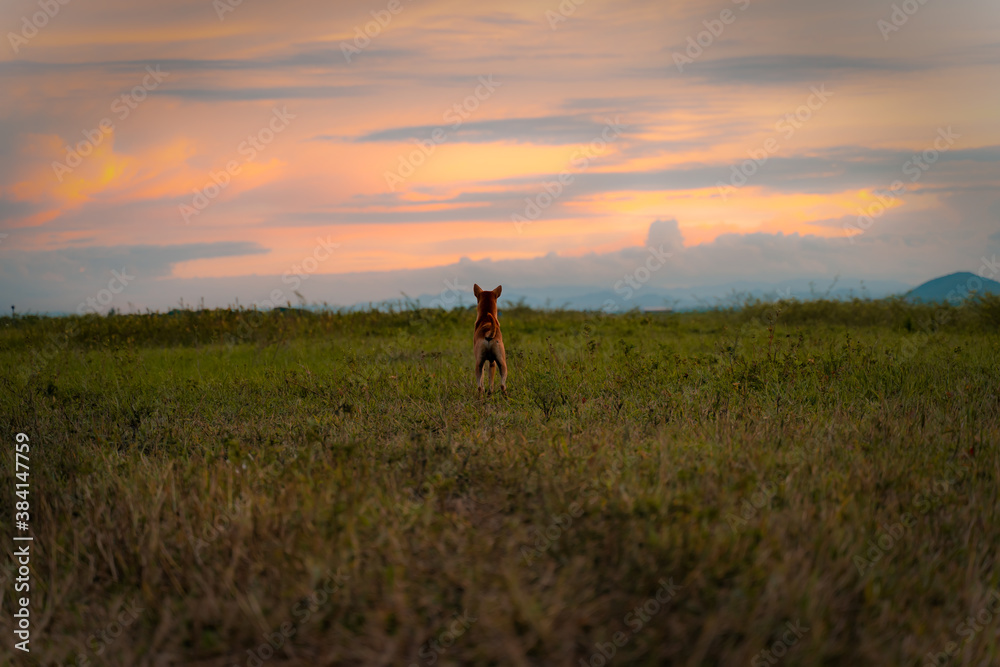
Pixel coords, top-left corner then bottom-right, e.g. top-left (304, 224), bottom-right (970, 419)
top-left (0, 299), bottom-right (1000, 667)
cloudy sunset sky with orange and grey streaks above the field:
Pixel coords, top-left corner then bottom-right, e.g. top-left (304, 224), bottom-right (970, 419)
top-left (0, 0), bottom-right (1000, 312)
